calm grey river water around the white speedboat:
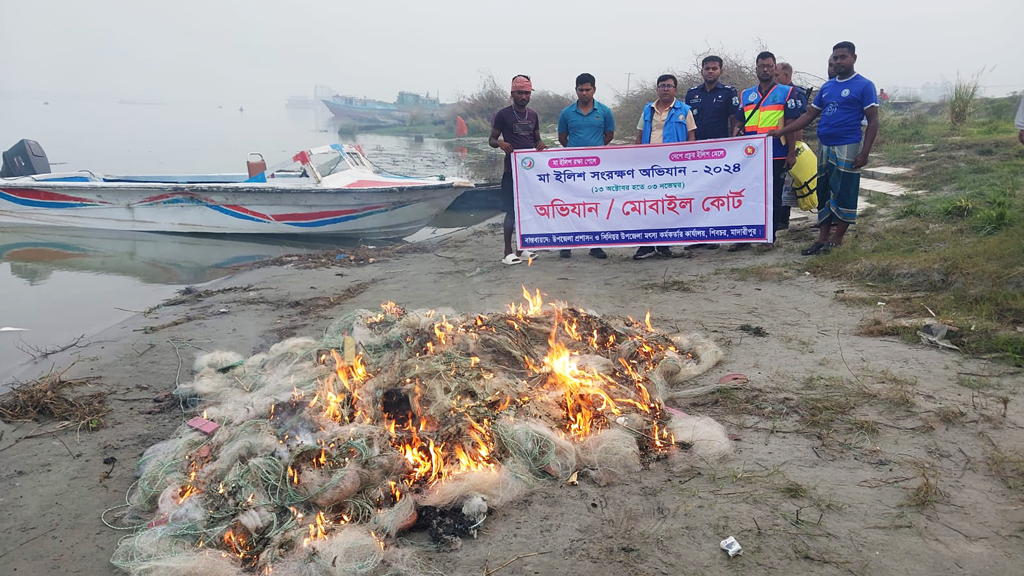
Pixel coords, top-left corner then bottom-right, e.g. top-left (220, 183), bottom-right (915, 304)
top-left (0, 99), bottom-right (501, 377)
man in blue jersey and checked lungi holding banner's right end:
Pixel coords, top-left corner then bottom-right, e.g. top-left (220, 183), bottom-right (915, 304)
top-left (769, 42), bottom-right (879, 256)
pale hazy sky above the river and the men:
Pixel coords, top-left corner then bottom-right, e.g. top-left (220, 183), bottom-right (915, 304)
top-left (0, 0), bottom-right (1024, 105)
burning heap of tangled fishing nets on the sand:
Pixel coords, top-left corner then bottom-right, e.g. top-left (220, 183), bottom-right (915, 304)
top-left (112, 289), bottom-right (729, 576)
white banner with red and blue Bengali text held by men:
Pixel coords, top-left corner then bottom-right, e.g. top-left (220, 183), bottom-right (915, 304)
top-left (512, 136), bottom-right (772, 250)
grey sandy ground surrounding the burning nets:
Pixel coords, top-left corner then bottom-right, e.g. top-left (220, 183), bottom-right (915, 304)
top-left (0, 220), bottom-right (1024, 576)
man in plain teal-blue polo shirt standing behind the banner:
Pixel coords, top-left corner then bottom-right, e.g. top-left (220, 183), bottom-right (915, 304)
top-left (558, 72), bottom-right (615, 260)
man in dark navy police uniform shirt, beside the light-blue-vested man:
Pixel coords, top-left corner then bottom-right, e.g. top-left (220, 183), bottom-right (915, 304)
top-left (683, 56), bottom-right (739, 250)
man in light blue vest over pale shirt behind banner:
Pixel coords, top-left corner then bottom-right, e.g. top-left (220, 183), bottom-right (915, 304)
top-left (633, 74), bottom-right (697, 260)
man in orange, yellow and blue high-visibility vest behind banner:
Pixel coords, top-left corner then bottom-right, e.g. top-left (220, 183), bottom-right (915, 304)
top-left (729, 51), bottom-right (807, 252)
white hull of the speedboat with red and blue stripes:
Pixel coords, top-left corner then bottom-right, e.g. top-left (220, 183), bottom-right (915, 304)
top-left (0, 182), bottom-right (465, 239)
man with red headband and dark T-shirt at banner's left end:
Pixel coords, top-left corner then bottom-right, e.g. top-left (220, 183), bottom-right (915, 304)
top-left (487, 74), bottom-right (547, 265)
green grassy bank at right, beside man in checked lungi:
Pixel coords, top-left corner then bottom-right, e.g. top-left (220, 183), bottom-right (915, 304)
top-left (809, 95), bottom-right (1024, 366)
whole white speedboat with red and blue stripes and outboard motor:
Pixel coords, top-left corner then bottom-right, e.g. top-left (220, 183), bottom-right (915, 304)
top-left (0, 140), bottom-right (473, 239)
